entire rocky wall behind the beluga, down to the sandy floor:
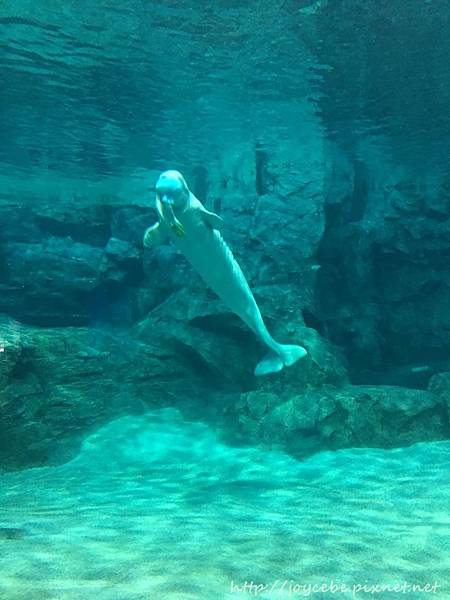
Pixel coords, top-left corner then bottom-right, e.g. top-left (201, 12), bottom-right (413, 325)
top-left (0, 143), bottom-right (450, 467)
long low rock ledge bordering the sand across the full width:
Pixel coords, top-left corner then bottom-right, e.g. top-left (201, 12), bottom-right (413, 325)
top-left (0, 310), bottom-right (450, 468)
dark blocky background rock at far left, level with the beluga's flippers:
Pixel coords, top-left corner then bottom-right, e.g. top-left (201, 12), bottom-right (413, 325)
top-left (0, 202), bottom-right (150, 326)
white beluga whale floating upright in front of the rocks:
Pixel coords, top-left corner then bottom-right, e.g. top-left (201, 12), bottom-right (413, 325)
top-left (144, 170), bottom-right (307, 375)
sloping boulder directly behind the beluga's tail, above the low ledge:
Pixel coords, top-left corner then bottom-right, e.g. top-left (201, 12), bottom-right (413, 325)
top-left (134, 255), bottom-right (347, 391)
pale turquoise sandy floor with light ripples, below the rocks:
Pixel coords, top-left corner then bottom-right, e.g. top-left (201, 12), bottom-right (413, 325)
top-left (0, 409), bottom-right (450, 600)
